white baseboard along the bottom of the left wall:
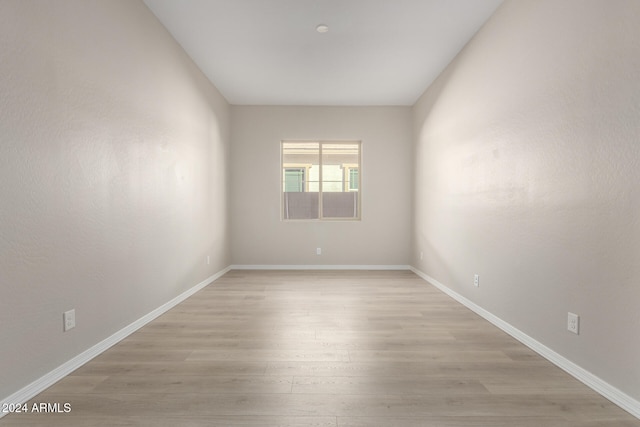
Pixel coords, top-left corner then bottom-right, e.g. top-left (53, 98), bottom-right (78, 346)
top-left (0, 267), bottom-right (231, 418)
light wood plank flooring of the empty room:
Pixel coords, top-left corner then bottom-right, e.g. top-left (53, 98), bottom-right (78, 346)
top-left (0, 271), bottom-right (640, 427)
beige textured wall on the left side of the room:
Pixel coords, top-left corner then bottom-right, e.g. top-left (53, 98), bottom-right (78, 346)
top-left (0, 0), bottom-right (230, 398)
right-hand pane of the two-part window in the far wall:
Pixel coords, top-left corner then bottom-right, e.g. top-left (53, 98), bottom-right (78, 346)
top-left (322, 143), bottom-right (360, 218)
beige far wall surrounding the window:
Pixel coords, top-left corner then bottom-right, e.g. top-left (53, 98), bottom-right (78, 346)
top-left (231, 106), bottom-right (411, 265)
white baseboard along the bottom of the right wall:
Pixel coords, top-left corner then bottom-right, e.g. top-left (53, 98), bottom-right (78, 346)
top-left (410, 267), bottom-right (640, 418)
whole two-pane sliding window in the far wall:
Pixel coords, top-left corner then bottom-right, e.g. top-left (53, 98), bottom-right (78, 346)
top-left (281, 141), bottom-right (361, 220)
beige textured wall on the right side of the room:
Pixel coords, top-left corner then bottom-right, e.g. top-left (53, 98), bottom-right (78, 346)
top-left (412, 0), bottom-right (640, 400)
